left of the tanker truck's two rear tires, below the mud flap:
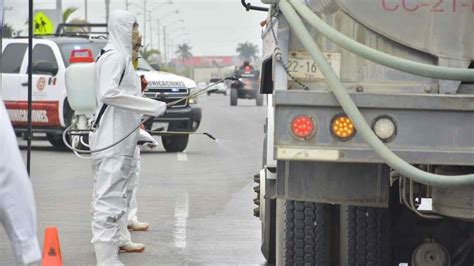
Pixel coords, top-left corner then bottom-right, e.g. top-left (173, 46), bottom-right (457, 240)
top-left (277, 200), bottom-right (331, 265)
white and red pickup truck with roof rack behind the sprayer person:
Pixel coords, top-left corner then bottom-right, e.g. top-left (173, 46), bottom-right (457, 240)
top-left (0, 36), bottom-right (201, 152)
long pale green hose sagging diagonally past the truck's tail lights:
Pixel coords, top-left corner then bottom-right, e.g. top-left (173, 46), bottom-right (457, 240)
top-left (280, 0), bottom-right (474, 188)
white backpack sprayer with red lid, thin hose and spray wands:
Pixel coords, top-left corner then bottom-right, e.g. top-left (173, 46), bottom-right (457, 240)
top-left (63, 49), bottom-right (237, 156)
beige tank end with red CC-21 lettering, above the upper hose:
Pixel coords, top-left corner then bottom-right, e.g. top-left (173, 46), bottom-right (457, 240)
top-left (306, 0), bottom-right (474, 60)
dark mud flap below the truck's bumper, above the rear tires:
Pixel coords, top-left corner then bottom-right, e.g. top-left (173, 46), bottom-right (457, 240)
top-left (276, 161), bottom-right (390, 207)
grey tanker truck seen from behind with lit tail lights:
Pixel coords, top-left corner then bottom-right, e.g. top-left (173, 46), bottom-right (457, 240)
top-left (254, 0), bottom-right (474, 265)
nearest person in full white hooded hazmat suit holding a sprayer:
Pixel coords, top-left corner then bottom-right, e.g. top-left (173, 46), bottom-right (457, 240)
top-left (90, 11), bottom-right (166, 265)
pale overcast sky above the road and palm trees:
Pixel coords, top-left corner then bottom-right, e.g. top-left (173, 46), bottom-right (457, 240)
top-left (5, 0), bottom-right (266, 55)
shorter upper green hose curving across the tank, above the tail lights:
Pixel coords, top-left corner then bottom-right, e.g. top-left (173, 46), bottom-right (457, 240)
top-left (290, 0), bottom-right (474, 81)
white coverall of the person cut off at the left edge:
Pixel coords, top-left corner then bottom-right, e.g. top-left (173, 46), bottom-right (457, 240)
top-left (0, 98), bottom-right (41, 264)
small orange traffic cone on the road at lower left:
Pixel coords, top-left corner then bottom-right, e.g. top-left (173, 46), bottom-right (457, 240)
top-left (41, 227), bottom-right (63, 266)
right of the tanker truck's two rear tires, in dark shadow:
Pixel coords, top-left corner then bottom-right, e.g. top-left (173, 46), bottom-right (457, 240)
top-left (346, 206), bottom-right (391, 266)
